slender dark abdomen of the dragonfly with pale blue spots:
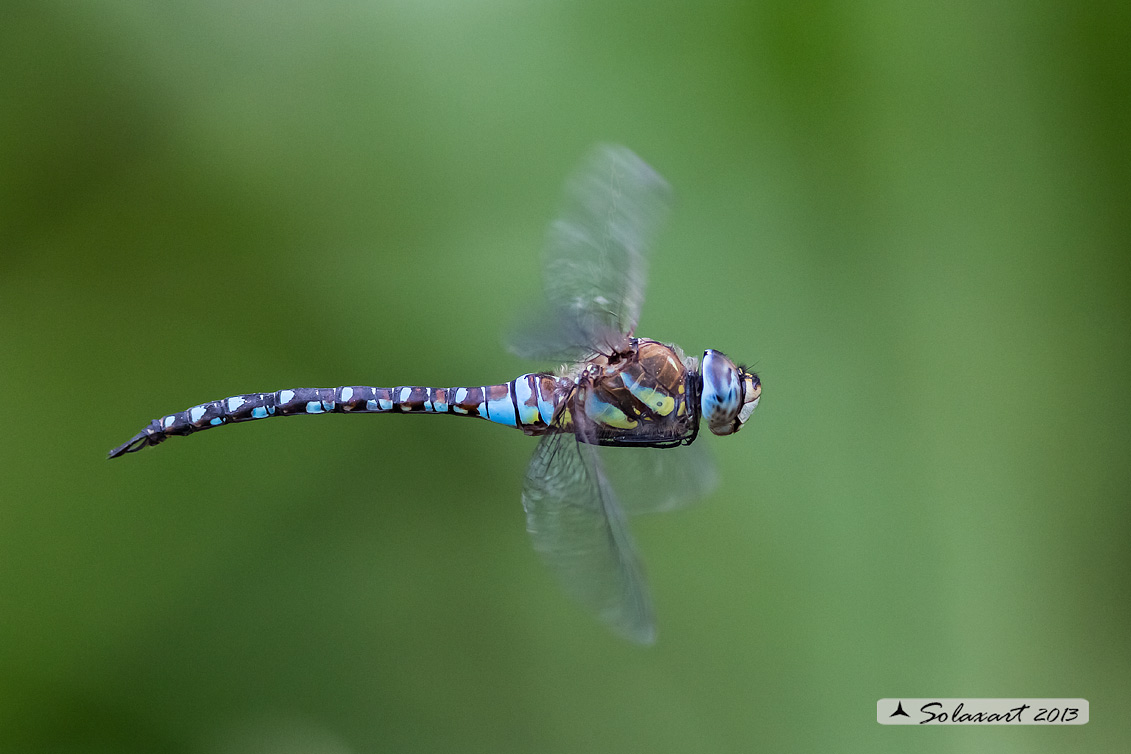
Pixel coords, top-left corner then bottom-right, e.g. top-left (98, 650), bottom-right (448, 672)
top-left (110, 373), bottom-right (561, 458)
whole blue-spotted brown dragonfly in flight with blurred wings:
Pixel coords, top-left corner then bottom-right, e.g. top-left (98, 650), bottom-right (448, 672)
top-left (110, 145), bottom-right (761, 644)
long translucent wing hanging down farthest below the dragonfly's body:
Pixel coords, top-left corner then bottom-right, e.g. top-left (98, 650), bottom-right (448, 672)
top-left (523, 433), bottom-right (656, 644)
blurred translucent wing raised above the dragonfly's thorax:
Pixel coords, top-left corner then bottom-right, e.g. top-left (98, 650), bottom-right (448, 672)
top-left (510, 145), bottom-right (671, 359)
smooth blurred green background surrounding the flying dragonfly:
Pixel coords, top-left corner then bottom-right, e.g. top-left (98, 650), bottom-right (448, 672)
top-left (0, 0), bottom-right (1131, 754)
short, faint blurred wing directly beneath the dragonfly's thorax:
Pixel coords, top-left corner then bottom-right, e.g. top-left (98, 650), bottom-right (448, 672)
top-left (601, 442), bottom-right (718, 515)
